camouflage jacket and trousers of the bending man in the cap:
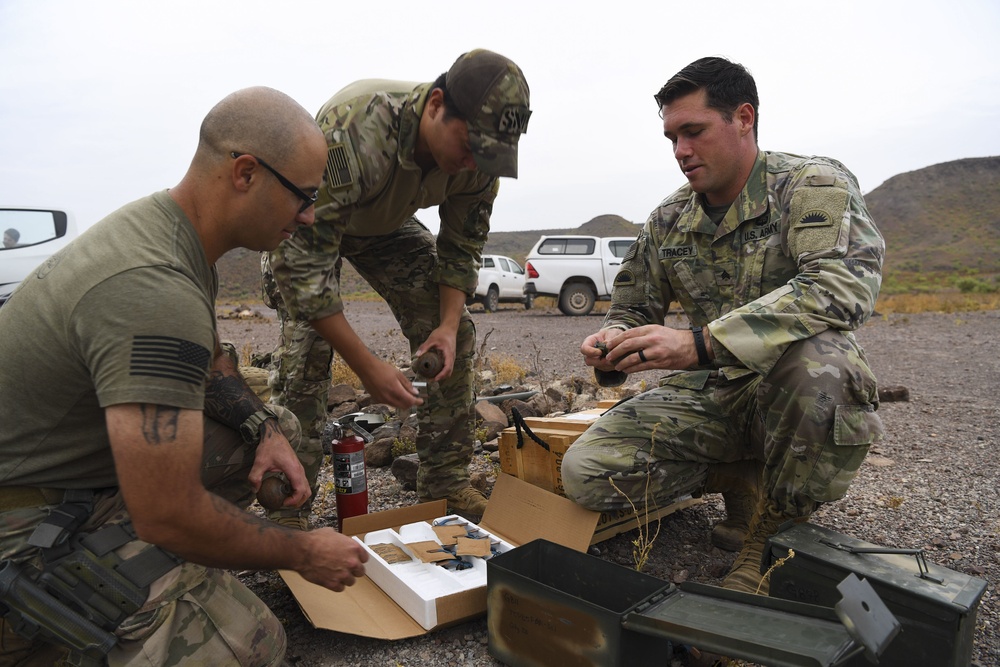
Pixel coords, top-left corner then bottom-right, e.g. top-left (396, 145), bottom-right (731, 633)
top-left (261, 80), bottom-right (499, 498)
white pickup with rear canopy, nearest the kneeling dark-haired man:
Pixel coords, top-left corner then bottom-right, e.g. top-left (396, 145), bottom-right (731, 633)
top-left (524, 235), bottom-right (635, 315)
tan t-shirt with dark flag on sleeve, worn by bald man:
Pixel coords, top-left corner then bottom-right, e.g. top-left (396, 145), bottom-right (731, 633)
top-left (0, 191), bottom-right (218, 488)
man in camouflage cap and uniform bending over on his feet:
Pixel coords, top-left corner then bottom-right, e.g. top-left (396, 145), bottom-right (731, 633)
top-left (261, 49), bottom-right (531, 518)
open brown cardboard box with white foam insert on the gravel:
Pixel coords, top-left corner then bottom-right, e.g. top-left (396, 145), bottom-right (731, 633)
top-left (281, 475), bottom-right (600, 639)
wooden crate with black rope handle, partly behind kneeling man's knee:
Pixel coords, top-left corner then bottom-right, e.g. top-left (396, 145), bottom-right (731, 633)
top-left (500, 403), bottom-right (701, 544)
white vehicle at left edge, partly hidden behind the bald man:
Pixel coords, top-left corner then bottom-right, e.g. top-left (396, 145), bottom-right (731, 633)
top-left (0, 207), bottom-right (77, 305)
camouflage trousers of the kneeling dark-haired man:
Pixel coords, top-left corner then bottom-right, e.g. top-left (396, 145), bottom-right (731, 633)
top-left (562, 331), bottom-right (883, 516)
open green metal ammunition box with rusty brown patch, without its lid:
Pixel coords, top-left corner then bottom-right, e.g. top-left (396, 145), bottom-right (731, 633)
top-left (486, 540), bottom-right (673, 667)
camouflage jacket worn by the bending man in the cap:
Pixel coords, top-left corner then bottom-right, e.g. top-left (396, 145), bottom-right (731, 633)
top-left (265, 79), bottom-right (499, 320)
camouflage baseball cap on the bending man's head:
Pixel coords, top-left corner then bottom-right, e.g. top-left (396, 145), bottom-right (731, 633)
top-left (445, 49), bottom-right (531, 178)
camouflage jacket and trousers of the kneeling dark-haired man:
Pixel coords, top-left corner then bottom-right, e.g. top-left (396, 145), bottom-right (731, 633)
top-left (562, 152), bottom-right (884, 516)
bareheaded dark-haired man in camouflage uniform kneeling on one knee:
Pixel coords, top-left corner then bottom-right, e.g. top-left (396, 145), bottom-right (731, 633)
top-left (562, 58), bottom-right (885, 594)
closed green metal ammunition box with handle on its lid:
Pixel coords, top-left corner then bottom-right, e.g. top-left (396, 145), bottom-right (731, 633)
top-left (764, 523), bottom-right (986, 667)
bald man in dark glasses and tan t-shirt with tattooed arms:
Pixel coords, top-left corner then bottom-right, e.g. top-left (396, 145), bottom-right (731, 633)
top-left (0, 88), bottom-right (366, 665)
